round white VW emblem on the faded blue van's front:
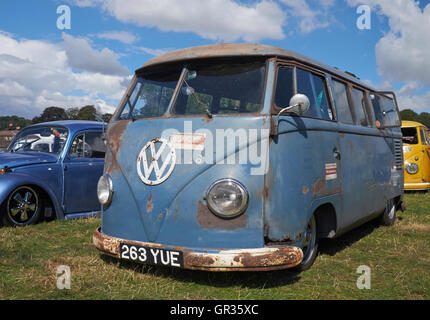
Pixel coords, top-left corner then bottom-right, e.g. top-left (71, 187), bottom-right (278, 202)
top-left (137, 138), bottom-right (176, 186)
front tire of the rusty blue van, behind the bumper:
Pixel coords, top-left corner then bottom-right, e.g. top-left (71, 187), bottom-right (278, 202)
top-left (296, 216), bottom-right (318, 271)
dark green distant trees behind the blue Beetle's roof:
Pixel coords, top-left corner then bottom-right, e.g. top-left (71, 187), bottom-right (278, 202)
top-left (0, 106), bottom-right (112, 130)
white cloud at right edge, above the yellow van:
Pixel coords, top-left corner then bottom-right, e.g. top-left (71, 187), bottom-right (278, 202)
top-left (348, 0), bottom-right (430, 110)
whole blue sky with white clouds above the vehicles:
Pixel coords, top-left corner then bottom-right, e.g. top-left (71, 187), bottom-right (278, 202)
top-left (0, 0), bottom-right (430, 118)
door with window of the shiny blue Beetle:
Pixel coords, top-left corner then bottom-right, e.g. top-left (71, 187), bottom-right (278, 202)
top-left (63, 131), bottom-right (106, 214)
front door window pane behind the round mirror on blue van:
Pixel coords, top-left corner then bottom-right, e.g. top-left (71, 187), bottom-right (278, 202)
top-left (297, 68), bottom-right (333, 120)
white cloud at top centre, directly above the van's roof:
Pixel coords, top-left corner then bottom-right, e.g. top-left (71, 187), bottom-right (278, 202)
top-left (80, 0), bottom-right (286, 42)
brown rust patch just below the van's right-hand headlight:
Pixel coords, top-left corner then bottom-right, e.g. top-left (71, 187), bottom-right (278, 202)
top-left (197, 201), bottom-right (248, 230)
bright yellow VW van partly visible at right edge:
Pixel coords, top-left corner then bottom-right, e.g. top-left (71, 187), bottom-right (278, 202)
top-left (402, 121), bottom-right (430, 191)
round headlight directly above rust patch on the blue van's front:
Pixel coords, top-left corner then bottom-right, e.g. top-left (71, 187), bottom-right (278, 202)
top-left (206, 179), bottom-right (249, 218)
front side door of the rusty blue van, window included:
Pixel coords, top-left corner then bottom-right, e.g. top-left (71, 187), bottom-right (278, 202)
top-left (265, 65), bottom-right (341, 243)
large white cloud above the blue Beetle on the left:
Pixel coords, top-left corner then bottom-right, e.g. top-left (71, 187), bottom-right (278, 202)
top-left (0, 32), bottom-right (130, 118)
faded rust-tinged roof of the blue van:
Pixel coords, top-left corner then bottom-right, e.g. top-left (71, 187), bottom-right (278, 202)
top-left (136, 43), bottom-right (377, 91)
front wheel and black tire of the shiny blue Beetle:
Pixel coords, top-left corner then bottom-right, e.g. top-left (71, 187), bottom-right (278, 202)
top-left (1, 186), bottom-right (42, 227)
